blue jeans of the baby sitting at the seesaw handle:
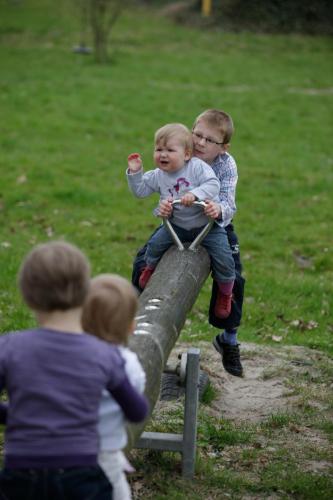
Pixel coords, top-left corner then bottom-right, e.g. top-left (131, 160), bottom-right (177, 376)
top-left (145, 224), bottom-right (235, 283)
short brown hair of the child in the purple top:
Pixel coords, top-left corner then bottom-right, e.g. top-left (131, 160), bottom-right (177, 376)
top-left (18, 241), bottom-right (90, 312)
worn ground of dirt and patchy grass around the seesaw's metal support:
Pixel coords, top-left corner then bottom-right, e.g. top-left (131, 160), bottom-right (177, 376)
top-left (132, 342), bottom-right (333, 500)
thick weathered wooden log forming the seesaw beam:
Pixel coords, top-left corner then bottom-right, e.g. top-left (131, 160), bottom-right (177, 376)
top-left (127, 246), bottom-right (210, 449)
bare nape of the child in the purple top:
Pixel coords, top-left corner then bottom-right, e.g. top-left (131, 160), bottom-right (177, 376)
top-left (35, 307), bottom-right (83, 334)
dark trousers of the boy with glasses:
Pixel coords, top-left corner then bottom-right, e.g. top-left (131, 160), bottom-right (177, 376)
top-left (132, 224), bottom-right (245, 330)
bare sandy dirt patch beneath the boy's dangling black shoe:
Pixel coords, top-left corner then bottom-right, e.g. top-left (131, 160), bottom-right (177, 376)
top-left (163, 342), bottom-right (332, 422)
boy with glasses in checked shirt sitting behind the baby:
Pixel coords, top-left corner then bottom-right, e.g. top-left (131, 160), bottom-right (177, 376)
top-left (132, 109), bottom-right (245, 376)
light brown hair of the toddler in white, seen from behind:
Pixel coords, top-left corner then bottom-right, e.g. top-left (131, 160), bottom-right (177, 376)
top-left (82, 274), bottom-right (138, 345)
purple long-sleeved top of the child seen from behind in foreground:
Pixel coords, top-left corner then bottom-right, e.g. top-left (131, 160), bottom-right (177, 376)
top-left (0, 328), bottom-right (147, 468)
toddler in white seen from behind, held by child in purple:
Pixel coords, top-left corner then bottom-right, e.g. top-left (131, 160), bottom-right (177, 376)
top-left (82, 274), bottom-right (146, 500)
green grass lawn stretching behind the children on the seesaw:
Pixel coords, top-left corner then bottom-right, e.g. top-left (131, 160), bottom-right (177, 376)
top-left (0, 0), bottom-right (333, 498)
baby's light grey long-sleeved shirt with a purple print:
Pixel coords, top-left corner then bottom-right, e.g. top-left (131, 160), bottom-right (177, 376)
top-left (127, 157), bottom-right (220, 229)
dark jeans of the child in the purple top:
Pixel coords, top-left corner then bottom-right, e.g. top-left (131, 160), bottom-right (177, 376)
top-left (0, 466), bottom-right (112, 500)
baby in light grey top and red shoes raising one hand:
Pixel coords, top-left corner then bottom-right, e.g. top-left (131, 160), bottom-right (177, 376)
top-left (127, 123), bottom-right (235, 318)
